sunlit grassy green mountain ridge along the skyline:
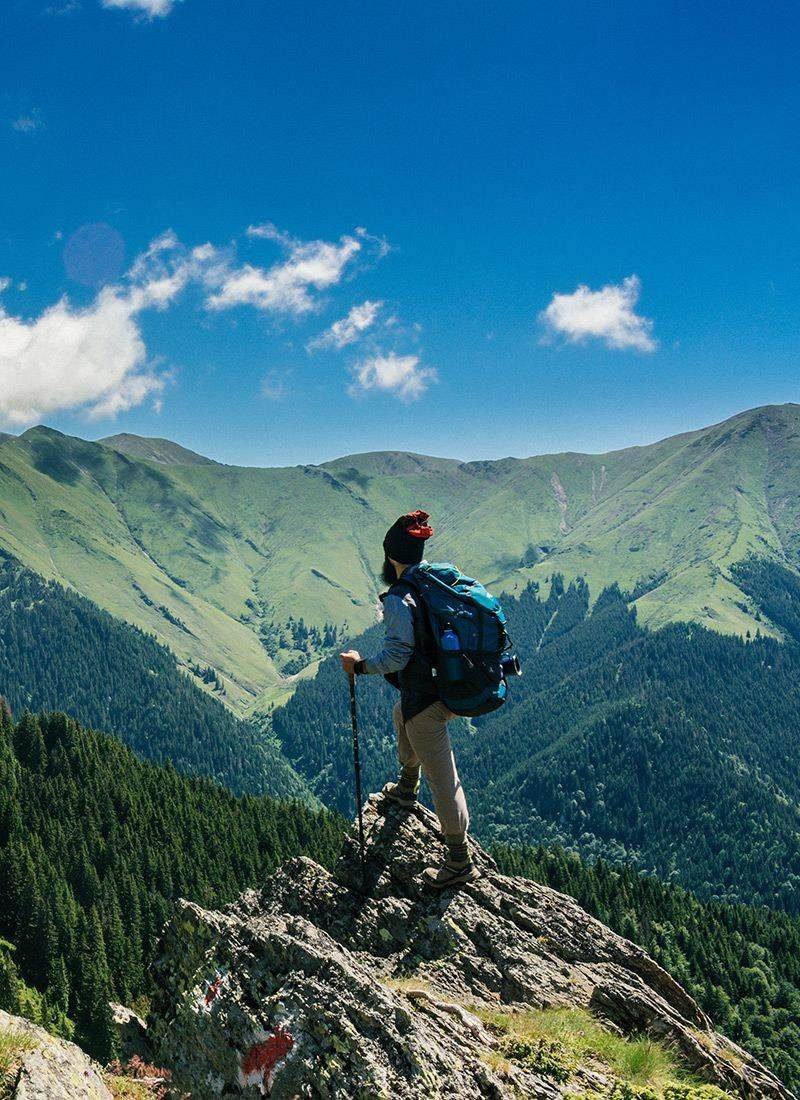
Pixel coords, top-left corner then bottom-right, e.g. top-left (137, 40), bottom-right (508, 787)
top-left (0, 405), bottom-right (800, 710)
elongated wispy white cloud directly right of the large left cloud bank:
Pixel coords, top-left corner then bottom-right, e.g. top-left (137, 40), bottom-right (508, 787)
top-left (211, 226), bottom-right (361, 317)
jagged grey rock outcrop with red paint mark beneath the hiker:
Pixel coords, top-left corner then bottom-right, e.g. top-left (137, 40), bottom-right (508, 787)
top-left (150, 795), bottom-right (791, 1100)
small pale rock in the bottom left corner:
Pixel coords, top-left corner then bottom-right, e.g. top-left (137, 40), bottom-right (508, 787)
top-left (0, 1011), bottom-right (113, 1100)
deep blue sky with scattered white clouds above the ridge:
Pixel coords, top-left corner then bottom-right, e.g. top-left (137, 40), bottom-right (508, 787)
top-left (0, 0), bottom-right (800, 464)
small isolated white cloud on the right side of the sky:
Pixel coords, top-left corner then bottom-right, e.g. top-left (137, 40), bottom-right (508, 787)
top-left (539, 275), bottom-right (658, 351)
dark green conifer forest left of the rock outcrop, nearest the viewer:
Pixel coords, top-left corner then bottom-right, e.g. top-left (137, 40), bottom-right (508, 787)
top-left (0, 704), bottom-right (343, 1060)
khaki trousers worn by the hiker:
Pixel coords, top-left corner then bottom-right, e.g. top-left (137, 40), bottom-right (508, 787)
top-left (392, 703), bottom-right (470, 837)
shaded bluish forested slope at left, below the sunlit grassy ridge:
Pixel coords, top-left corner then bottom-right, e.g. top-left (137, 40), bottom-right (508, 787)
top-left (0, 561), bottom-right (313, 801)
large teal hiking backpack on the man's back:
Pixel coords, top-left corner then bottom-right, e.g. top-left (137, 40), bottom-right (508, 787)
top-left (403, 561), bottom-right (519, 717)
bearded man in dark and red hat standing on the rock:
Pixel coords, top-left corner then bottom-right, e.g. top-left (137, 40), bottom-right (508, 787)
top-left (340, 512), bottom-right (479, 890)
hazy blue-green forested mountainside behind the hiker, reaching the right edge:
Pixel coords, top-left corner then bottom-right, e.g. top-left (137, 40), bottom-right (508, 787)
top-left (271, 559), bottom-right (800, 913)
